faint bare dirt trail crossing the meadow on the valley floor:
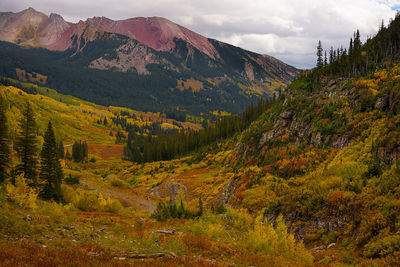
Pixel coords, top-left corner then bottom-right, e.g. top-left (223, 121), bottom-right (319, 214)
top-left (80, 177), bottom-right (157, 212)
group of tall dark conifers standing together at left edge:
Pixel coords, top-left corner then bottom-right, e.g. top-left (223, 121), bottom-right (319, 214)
top-left (0, 95), bottom-right (63, 202)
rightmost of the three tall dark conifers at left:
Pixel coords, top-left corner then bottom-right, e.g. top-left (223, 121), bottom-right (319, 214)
top-left (39, 122), bottom-right (63, 202)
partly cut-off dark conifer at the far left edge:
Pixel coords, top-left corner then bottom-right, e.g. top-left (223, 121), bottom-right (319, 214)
top-left (0, 94), bottom-right (10, 183)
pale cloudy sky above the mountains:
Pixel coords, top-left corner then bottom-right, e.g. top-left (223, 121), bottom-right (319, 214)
top-left (0, 0), bottom-right (400, 68)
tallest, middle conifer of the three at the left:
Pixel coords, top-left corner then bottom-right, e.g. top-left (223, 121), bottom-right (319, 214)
top-left (14, 102), bottom-right (38, 186)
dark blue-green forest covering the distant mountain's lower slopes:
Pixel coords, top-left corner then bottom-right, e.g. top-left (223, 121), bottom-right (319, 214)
top-left (0, 36), bottom-right (272, 118)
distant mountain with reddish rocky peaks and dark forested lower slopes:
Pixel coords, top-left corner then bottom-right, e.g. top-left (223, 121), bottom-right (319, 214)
top-left (0, 8), bottom-right (299, 116)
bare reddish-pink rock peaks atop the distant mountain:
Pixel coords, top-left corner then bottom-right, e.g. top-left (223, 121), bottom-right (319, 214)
top-left (0, 8), bottom-right (218, 59)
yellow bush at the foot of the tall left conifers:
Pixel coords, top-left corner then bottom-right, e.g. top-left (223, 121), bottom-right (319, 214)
top-left (6, 174), bottom-right (38, 209)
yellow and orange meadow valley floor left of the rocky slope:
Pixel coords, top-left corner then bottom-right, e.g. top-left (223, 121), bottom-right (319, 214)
top-left (0, 79), bottom-right (318, 266)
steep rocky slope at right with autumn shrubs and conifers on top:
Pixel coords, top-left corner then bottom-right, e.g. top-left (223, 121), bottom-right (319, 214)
top-left (214, 16), bottom-right (400, 266)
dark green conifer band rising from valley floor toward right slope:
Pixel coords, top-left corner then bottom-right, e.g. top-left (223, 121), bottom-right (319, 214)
top-left (124, 99), bottom-right (273, 163)
